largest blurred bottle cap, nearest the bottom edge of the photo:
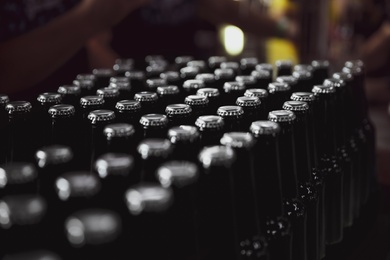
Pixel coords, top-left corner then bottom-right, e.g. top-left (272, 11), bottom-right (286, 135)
top-left (65, 209), bottom-right (122, 247)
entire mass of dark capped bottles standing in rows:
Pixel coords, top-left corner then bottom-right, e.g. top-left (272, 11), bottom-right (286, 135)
top-left (0, 56), bottom-right (376, 260)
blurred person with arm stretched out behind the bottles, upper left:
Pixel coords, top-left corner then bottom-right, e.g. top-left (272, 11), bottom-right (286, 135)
top-left (0, 0), bottom-right (297, 99)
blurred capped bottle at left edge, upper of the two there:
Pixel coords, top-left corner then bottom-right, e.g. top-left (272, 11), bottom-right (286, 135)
top-left (0, 162), bottom-right (38, 198)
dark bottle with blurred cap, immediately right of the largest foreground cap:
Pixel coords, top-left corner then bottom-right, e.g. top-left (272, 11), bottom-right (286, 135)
top-left (123, 183), bottom-right (174, 260)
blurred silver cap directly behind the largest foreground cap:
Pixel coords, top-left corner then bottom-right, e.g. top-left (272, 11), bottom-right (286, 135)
top-left (55, 171), bottom-right (101, 201)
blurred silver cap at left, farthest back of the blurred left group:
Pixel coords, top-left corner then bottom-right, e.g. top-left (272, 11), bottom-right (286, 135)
top-left (35, 145), bottom-right (73, 168)
